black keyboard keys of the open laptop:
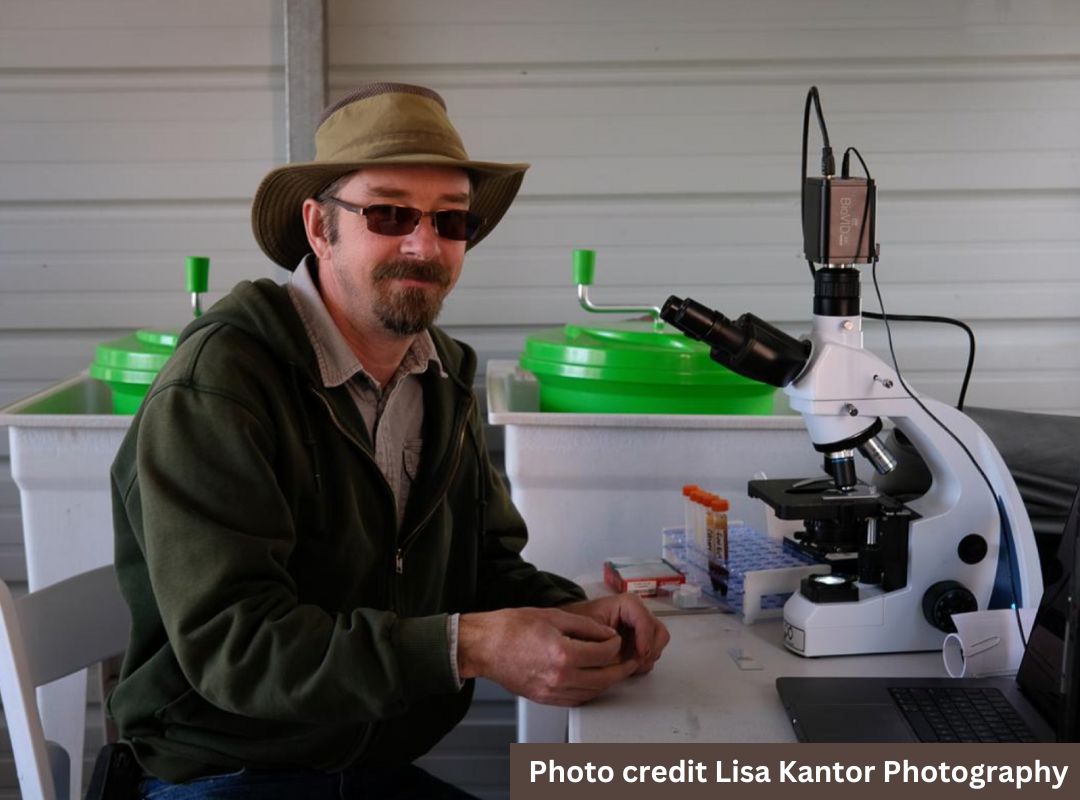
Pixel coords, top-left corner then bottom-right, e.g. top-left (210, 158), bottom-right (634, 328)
top-left (889, 687), bottom-right (1038, 742)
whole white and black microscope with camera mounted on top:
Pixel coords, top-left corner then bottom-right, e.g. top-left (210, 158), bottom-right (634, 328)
top-left (661, 87), bottom-right (1042, 656)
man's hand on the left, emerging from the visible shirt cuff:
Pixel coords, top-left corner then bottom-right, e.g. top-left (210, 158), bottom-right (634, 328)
top-left (458, 604), bottom-right (639, 706)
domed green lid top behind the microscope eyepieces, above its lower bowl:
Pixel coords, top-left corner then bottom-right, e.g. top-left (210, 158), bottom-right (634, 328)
top-left (521, 322), bottom-right (757, 387)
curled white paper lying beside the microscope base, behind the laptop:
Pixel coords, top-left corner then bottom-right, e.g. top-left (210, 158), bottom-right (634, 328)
top-left (942, 608), bottom-right (1036, 678)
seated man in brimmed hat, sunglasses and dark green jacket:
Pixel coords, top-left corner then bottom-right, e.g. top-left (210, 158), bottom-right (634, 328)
top-left (109, 83), bottom-right (667, 799)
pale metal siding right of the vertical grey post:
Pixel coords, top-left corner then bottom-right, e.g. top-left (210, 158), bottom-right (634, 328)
top-left (330, 0), bottom-right (1080, 421)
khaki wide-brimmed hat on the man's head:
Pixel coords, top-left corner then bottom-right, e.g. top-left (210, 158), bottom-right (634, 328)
top-left (252, 83), bottom-right (529, 270)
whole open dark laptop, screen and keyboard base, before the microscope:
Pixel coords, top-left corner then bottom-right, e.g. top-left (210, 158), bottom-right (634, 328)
top-left (777, 477), bottom-right (1080, 742)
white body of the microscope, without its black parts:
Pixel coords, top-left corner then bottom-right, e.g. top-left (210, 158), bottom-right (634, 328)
top-left (784, 314), bottom-right (1042, 656)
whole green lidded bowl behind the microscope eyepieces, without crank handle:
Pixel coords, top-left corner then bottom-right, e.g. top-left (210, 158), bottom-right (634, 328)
top-left (521, 322), bottom-right (775, 413)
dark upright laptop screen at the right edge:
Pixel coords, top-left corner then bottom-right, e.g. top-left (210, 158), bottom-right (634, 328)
top-left (1016, 481), bottom-right (1080, 742)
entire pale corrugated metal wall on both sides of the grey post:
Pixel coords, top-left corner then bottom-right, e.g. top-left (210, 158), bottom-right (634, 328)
top-left (0, 0), bottom-right (1080, 796)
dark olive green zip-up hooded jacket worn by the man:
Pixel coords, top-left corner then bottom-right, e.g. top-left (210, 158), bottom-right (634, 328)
top-left (108, 280), bottom-right (582, 782)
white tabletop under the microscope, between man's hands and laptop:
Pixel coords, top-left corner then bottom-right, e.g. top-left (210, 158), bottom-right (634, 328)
top-left (569, 613), bottom-right (945, 743)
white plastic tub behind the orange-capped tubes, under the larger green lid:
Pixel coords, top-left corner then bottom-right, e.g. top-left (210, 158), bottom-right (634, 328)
top-left (487, 361), bottom-right (821, 578)
